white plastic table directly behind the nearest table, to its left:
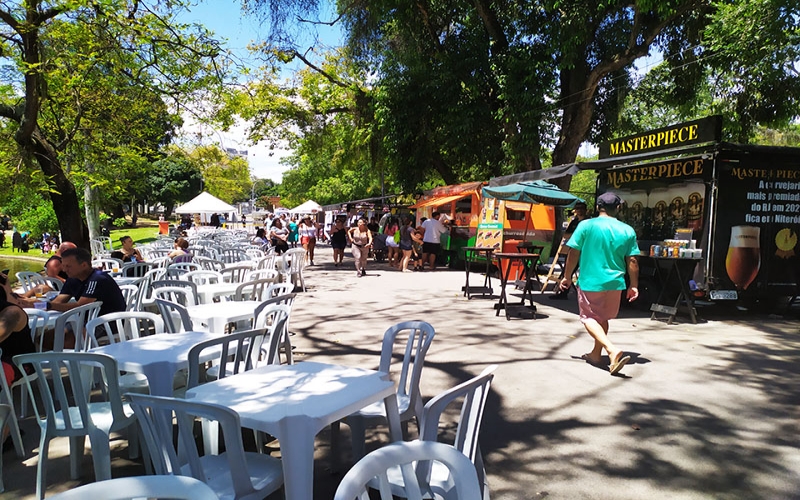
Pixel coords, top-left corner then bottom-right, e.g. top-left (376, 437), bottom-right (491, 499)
top-left (91, 332), bottom-right (219, 396)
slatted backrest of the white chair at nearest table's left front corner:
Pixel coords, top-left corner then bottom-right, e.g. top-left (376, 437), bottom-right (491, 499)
top-left (129, 394), bottom-right (270, 498)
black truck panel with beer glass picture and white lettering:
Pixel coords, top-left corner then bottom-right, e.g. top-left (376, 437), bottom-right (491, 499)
top-left (712, 161), bottom-right (800, 293)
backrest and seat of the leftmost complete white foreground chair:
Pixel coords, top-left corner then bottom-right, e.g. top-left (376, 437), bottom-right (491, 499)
top-left (14, 352), bottom-right (133, 436)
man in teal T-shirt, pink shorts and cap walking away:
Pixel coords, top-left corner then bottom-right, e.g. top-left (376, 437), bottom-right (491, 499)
top-left (560, 193), bottom-right (640, 375)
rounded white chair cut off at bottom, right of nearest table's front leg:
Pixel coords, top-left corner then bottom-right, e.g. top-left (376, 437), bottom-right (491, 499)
top-left (333, 441), bottom-right (481, 500)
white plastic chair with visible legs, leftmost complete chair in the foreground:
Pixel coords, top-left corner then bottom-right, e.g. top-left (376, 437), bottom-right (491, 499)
top-left (14, 352), bottom-right (136, 499)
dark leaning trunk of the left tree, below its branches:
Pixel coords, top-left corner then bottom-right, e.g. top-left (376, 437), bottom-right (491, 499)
top-left (29, 127), bottom-right (90, 250)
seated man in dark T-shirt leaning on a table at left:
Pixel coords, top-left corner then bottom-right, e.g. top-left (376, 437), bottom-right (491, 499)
top-left (45, 248), bottom-right (125, 348)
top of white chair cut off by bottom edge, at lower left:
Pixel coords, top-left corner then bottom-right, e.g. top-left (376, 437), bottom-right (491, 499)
top-left (48, 476), bottom-right (219, 500)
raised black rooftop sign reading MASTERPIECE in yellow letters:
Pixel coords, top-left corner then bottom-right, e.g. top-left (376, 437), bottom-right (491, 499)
top-left (599, 116), bottom-right (722, 159)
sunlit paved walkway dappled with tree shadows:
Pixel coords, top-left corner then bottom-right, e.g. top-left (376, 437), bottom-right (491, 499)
top-left (1, 247), bottom-right (800, 500)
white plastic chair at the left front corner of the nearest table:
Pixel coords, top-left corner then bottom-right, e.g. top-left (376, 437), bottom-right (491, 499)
top-left (130, 394), bottom-right (283, 500)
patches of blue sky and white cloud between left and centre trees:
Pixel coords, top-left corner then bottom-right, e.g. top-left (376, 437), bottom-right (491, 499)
top-left (179, 0), bottom-right (340, 182)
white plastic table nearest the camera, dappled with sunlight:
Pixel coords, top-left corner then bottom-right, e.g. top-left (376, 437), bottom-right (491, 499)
top-left (186, 361), bottom-right (402, 500)
